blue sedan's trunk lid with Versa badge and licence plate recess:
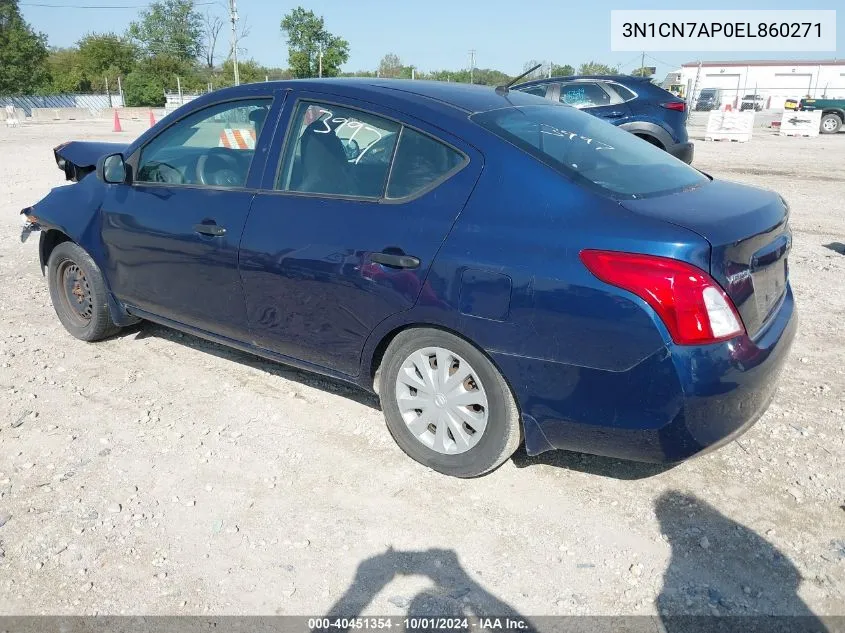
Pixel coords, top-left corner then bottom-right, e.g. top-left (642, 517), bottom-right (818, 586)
top-left (622, 181), bottom-right (792, 337)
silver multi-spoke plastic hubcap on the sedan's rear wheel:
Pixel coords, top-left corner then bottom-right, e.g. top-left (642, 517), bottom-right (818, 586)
top-left (396, 347), bottom-right (489, 455)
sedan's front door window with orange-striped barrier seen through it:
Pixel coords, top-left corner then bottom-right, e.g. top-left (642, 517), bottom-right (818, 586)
top-left (133, 98), bottom-right (272, 187)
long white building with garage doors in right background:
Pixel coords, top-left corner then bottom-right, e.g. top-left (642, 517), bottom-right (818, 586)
top-left (667, 59), bottom-right (845, 108)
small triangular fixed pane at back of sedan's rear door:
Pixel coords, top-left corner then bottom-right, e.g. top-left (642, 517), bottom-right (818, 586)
top-left (387, 127), bottom-right (465, 198)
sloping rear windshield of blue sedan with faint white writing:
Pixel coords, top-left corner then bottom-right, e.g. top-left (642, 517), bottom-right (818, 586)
top-left (471, 105), bottom-right (708, 199)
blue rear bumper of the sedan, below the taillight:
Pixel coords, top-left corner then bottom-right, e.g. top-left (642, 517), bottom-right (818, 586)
top-left (493, 288), bottom-right (797, 463)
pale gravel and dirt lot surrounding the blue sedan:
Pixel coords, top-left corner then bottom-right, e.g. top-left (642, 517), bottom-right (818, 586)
top-left (0, 116), bottom-right (845, 616)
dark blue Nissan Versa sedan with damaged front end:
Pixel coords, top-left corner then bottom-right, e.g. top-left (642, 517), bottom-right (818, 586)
top-left (22, 79), bottom-right (797, 477)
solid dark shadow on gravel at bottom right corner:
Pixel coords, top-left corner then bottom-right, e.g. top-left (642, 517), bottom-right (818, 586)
top-left (655, 491), bottom-right (828, 633)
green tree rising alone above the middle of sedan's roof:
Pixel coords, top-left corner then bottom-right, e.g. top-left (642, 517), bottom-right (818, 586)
top-left (281, 7), bottom-right (349, 78)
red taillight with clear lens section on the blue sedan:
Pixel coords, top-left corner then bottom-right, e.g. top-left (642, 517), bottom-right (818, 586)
top-left (581, 250), bottom-right (745, 345)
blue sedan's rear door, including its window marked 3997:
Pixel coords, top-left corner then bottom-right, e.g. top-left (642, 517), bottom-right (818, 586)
top-left (241, 94), bottom-right (482, 375)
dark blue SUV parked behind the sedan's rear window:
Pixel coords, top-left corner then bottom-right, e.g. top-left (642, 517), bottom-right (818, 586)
top-left (513, 75), bottom-right (694, 164)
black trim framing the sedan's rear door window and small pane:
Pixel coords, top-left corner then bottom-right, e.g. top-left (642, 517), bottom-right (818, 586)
top-left (268, 93), bottom-right (471, 204)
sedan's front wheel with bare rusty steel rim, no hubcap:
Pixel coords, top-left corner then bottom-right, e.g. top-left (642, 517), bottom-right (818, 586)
top-left (47, 242), bottom-right (120, 342)
